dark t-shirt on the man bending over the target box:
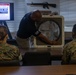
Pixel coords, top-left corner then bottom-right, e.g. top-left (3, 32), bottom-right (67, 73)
top-left (17, 13), bottom-right (41, 39)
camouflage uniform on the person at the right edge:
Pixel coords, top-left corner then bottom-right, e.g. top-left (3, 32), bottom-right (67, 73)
top-left (62, 39), bottom-right (76, 64)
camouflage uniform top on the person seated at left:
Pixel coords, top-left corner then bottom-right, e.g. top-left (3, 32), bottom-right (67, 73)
top-left (0, 43), bottom-right (20, 61)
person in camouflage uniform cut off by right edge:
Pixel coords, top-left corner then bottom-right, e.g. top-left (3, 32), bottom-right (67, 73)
top-left (62, 24), bottom-right (76, 64)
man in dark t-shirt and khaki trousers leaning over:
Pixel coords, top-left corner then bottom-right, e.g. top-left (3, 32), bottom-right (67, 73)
top-left (16, 10), bottom-right (56, 48)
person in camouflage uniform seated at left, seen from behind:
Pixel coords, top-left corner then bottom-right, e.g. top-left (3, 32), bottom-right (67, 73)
top-left (0, 25), bottom-right (21, 61)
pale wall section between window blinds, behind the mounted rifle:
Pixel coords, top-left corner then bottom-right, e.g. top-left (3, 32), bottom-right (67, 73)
top-left (25, 0), bottom-right (60, 12)
